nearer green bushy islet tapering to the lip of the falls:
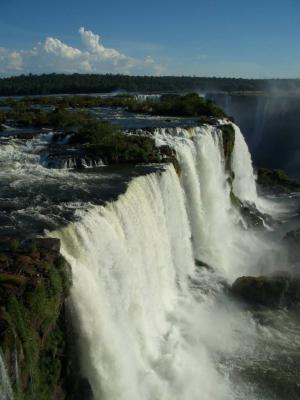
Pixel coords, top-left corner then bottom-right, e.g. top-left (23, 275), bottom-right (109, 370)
top-left (0, 101), bottom-right (178, 169)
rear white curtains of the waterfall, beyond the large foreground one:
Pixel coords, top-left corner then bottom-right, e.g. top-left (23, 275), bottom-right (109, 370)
top-left (154, 125), bottom-right (264, 280)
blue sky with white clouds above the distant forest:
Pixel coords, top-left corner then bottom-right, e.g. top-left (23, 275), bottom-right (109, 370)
top-left (0, 0), bottom-right (300, 78)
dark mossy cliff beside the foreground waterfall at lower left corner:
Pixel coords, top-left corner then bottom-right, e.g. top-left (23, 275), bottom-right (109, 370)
top-left (0, 238), bottom-right (70, 400)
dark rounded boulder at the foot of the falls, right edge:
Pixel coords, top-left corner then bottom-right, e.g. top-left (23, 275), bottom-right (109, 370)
top-left (231, 273), bottom-right (300, 308)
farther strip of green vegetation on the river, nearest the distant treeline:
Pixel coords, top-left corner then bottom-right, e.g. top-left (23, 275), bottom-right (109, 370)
top-left (0, 93), bottom-right (226, 128)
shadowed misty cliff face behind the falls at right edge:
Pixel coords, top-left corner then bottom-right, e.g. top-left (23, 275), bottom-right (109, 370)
top-left (208, 93), bottom-right (300, 179)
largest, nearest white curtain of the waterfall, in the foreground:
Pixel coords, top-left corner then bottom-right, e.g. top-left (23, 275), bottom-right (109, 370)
top-left (55, 167), bottom-right (237, 400)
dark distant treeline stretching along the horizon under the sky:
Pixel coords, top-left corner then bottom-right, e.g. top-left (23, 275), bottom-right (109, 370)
top-left (0, 74), bottom-right (300, 96)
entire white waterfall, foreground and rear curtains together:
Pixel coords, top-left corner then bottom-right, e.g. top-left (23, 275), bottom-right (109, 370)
top-left (52, 125), bottom-right (259, 400)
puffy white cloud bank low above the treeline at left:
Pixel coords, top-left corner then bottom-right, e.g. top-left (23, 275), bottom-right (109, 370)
top-left (0, 27), bottom-right (163, 75)
